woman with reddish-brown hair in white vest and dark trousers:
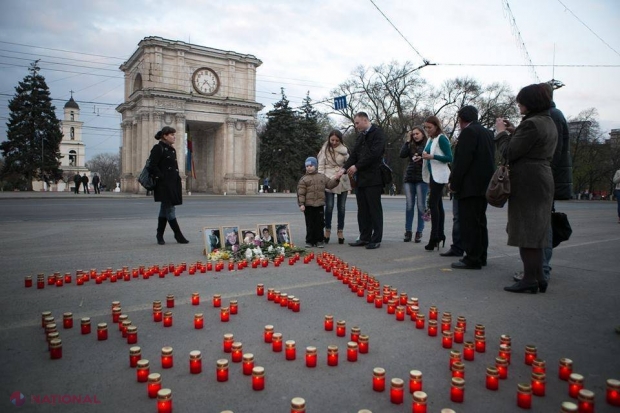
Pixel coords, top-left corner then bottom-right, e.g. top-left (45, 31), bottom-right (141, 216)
top-left (422, 116), bottom-right (452, 251)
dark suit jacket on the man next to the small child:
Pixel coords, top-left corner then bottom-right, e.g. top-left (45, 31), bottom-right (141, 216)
top-left (344, 125), bottom-right (385, 187)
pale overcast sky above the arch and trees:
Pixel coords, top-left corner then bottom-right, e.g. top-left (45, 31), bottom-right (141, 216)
top-left (0, 0), bottom-right (620, 159)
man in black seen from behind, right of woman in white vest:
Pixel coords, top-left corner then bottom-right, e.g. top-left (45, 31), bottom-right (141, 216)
top-left (449, 106), bottom-right (495, 270)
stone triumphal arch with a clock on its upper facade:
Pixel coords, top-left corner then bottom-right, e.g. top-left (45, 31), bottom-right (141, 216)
top-left (116, 37), bottom-right (263, 194)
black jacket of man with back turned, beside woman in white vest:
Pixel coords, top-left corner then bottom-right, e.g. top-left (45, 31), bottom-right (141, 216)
top-left (450, 122), bottom-right (495, 199)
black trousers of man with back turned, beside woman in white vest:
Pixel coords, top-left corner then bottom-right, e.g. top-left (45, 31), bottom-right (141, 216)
top-left (458, 196), bottom-right (489, 265)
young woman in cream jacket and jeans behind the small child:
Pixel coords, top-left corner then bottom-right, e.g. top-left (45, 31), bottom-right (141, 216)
top-left (317, 130), bottom-right (351, 244)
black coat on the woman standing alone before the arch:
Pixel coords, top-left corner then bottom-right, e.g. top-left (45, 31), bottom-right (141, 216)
top-left (149, 141), bottom-right (183, 205)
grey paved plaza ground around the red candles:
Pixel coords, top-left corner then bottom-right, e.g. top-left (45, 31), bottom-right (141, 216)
top-left (0, 193), bottom-right (620, 413)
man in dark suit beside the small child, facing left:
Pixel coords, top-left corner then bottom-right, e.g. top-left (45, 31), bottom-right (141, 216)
top-left (342, 112), bottom-right (385, 249)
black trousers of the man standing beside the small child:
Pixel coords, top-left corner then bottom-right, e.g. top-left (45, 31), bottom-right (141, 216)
top-left (355, 185), bottom-right (383, 243)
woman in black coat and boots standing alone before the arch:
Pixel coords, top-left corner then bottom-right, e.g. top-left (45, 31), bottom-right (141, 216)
top-left (149, 126), bottom-right (189, 245)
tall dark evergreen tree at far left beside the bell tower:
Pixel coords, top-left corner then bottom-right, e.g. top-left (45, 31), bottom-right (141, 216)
top-left (0, 60), bottom-right (62, 191)
